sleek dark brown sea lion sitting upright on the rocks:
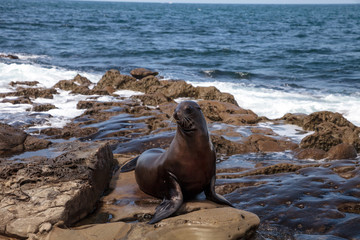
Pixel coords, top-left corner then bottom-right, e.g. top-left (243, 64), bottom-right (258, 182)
top-left (121, 101), bottom-right (232, 224)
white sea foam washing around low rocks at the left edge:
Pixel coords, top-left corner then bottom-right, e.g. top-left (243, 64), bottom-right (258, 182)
top-left (0, 63), bottom-right (101, 129)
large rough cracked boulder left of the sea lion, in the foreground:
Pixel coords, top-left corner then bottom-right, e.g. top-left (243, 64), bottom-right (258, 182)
top-left (0, 142), bottom-right (115, 238)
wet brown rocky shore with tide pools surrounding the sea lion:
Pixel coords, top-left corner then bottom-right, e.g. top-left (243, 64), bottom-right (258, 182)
top-left (0, 69), bottom-right (360, 239)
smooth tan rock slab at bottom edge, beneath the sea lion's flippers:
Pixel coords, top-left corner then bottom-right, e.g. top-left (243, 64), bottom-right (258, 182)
top-left (44, 207), bottom-right (260, 240)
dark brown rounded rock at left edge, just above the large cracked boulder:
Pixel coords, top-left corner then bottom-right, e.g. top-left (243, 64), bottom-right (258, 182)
top-left (0, 123), bottom-right (27, 155)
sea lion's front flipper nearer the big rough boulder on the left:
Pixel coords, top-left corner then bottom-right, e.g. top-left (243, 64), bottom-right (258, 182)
top-left (149, 173), bottom-right (183, 224)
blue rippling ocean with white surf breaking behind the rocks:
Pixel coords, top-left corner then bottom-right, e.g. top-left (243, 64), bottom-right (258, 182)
top-left (0, 0), bottom-right (360, 127)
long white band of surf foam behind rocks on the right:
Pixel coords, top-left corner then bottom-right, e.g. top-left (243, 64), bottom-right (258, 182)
top-left (190, 81), bottom-right (360, 126)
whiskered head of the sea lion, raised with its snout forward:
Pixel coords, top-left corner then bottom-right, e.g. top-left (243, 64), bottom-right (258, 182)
top-left (173, 101), bottom-right (207, 133)
